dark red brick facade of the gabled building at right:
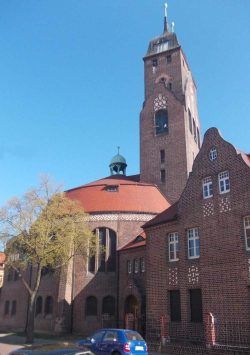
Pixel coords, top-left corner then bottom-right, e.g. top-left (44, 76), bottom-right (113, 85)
top-left (145, 128), bottom-right (250, 348)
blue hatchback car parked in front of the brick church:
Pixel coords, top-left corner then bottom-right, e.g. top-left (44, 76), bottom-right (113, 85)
top-left (79, 329), bottom-right (148, 355)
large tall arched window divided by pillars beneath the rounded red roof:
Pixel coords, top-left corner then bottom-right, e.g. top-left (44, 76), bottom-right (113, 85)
top-left (88, 227), bottom-right (116, 273)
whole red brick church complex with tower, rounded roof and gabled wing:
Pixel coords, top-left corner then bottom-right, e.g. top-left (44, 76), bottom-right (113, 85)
top-left (0, 4), bottom-right (250, 352)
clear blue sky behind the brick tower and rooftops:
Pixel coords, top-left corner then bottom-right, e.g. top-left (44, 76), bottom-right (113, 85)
top-left (0, 0), bottom-right (250, 205)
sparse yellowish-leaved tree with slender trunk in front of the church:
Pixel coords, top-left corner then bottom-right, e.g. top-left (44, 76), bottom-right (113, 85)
top-left (0, 177), bottom-right (95, 343)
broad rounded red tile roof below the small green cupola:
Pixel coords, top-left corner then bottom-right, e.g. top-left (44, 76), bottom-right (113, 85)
top-left (66, 175), bottom-right (170, 213)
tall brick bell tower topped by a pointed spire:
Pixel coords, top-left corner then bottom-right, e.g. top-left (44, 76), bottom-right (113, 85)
top-left (140, 4), bottom-right (201, 203)
